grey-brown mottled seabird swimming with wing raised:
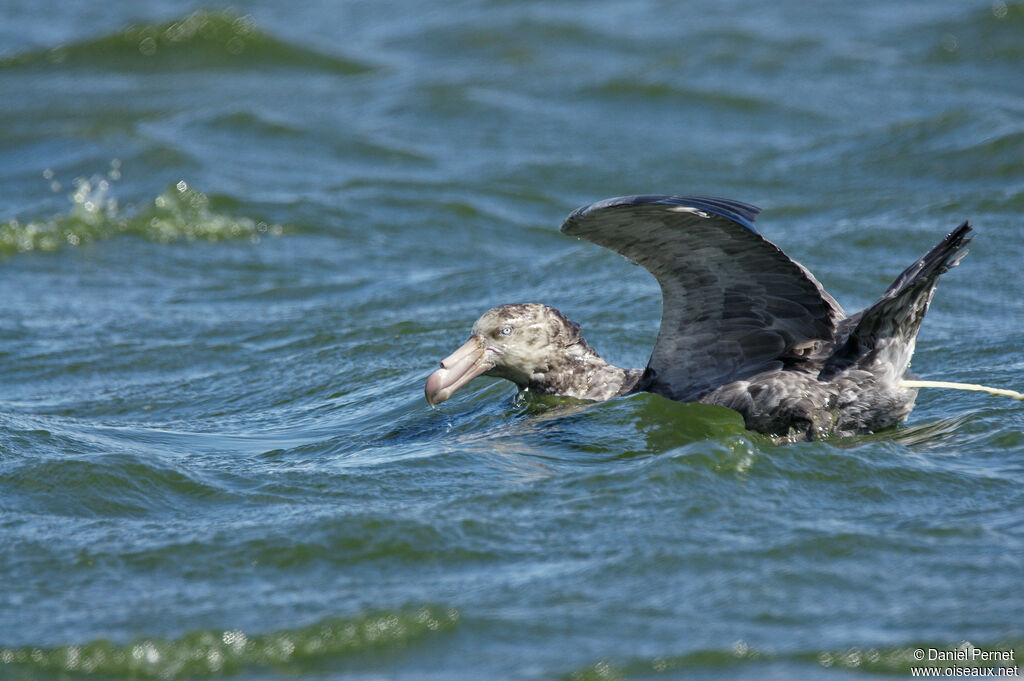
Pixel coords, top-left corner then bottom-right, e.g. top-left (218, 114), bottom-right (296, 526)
top-left (425, 196), bottom-right (991, 440)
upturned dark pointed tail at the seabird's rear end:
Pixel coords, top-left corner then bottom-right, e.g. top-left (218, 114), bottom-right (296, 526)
top-left (821, 221), bottom-right (971, 381)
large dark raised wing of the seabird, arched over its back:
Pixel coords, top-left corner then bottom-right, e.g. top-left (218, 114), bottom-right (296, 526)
top-left (561, 196), bottom-right (845, 401)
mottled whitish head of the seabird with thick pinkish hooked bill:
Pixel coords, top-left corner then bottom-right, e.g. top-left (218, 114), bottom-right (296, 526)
top-left (425, 303), bottom-right (580, 405)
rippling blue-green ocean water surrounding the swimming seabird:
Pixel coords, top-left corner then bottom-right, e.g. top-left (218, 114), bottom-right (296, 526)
top-left (0, 0), bottom-right (1024, 681)
